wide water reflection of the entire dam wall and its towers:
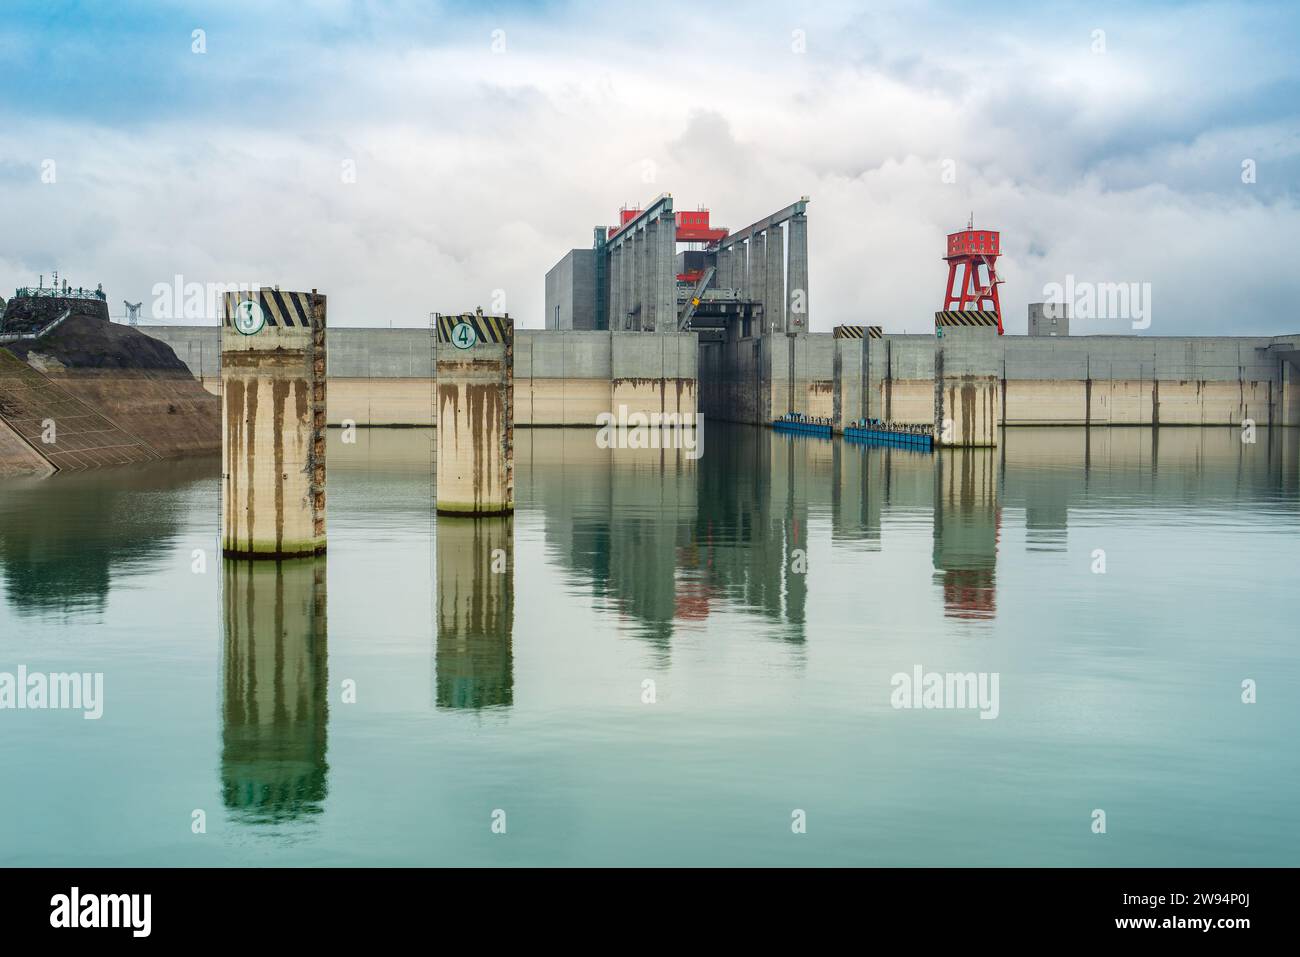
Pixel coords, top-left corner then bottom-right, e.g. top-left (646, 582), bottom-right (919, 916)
top-left (332, 423), bottom-right (1300, 650)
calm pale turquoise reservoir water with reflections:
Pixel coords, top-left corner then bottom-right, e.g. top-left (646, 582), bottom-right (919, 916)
top-left (0, 424), bottom-right (1300, 865)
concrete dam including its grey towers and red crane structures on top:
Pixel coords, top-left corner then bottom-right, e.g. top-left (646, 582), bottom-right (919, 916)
top-left (122, 194), bottom-right (1300, 436)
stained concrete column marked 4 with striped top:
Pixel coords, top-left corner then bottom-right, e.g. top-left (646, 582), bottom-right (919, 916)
top-left (437, 311), bottom-right (515, 516)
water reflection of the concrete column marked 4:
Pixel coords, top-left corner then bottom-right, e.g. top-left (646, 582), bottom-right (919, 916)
top-left (434, 516), bottom-right (515, 709)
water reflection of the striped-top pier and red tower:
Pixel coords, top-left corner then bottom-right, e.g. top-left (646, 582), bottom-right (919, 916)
top-left (933, 449), bottom-right (1001, 618)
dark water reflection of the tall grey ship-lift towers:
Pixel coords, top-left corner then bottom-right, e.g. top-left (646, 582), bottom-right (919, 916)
top-left (515, 425), bottom-right (809, 653)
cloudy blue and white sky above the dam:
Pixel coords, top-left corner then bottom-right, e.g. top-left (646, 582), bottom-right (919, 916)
top-left (0, 0), bottom-right (1300, 335)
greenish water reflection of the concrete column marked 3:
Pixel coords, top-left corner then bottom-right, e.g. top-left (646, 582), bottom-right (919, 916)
top-left (221, 558), bottom-right (329, 824)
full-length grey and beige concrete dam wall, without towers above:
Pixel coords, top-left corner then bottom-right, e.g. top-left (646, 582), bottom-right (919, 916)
top-left (143, 326), bottom-right (1300, 426)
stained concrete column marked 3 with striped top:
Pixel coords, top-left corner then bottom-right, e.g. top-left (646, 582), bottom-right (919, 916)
top-left (221, 289), bottom-right (325, 559)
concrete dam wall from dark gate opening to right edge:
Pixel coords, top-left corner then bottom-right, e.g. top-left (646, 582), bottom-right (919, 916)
top-left (699, 333), bottom-right (1300, 425)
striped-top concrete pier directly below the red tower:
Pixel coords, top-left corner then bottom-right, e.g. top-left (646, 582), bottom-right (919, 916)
top-left (935, 312), bottom-right (1002, 447)
